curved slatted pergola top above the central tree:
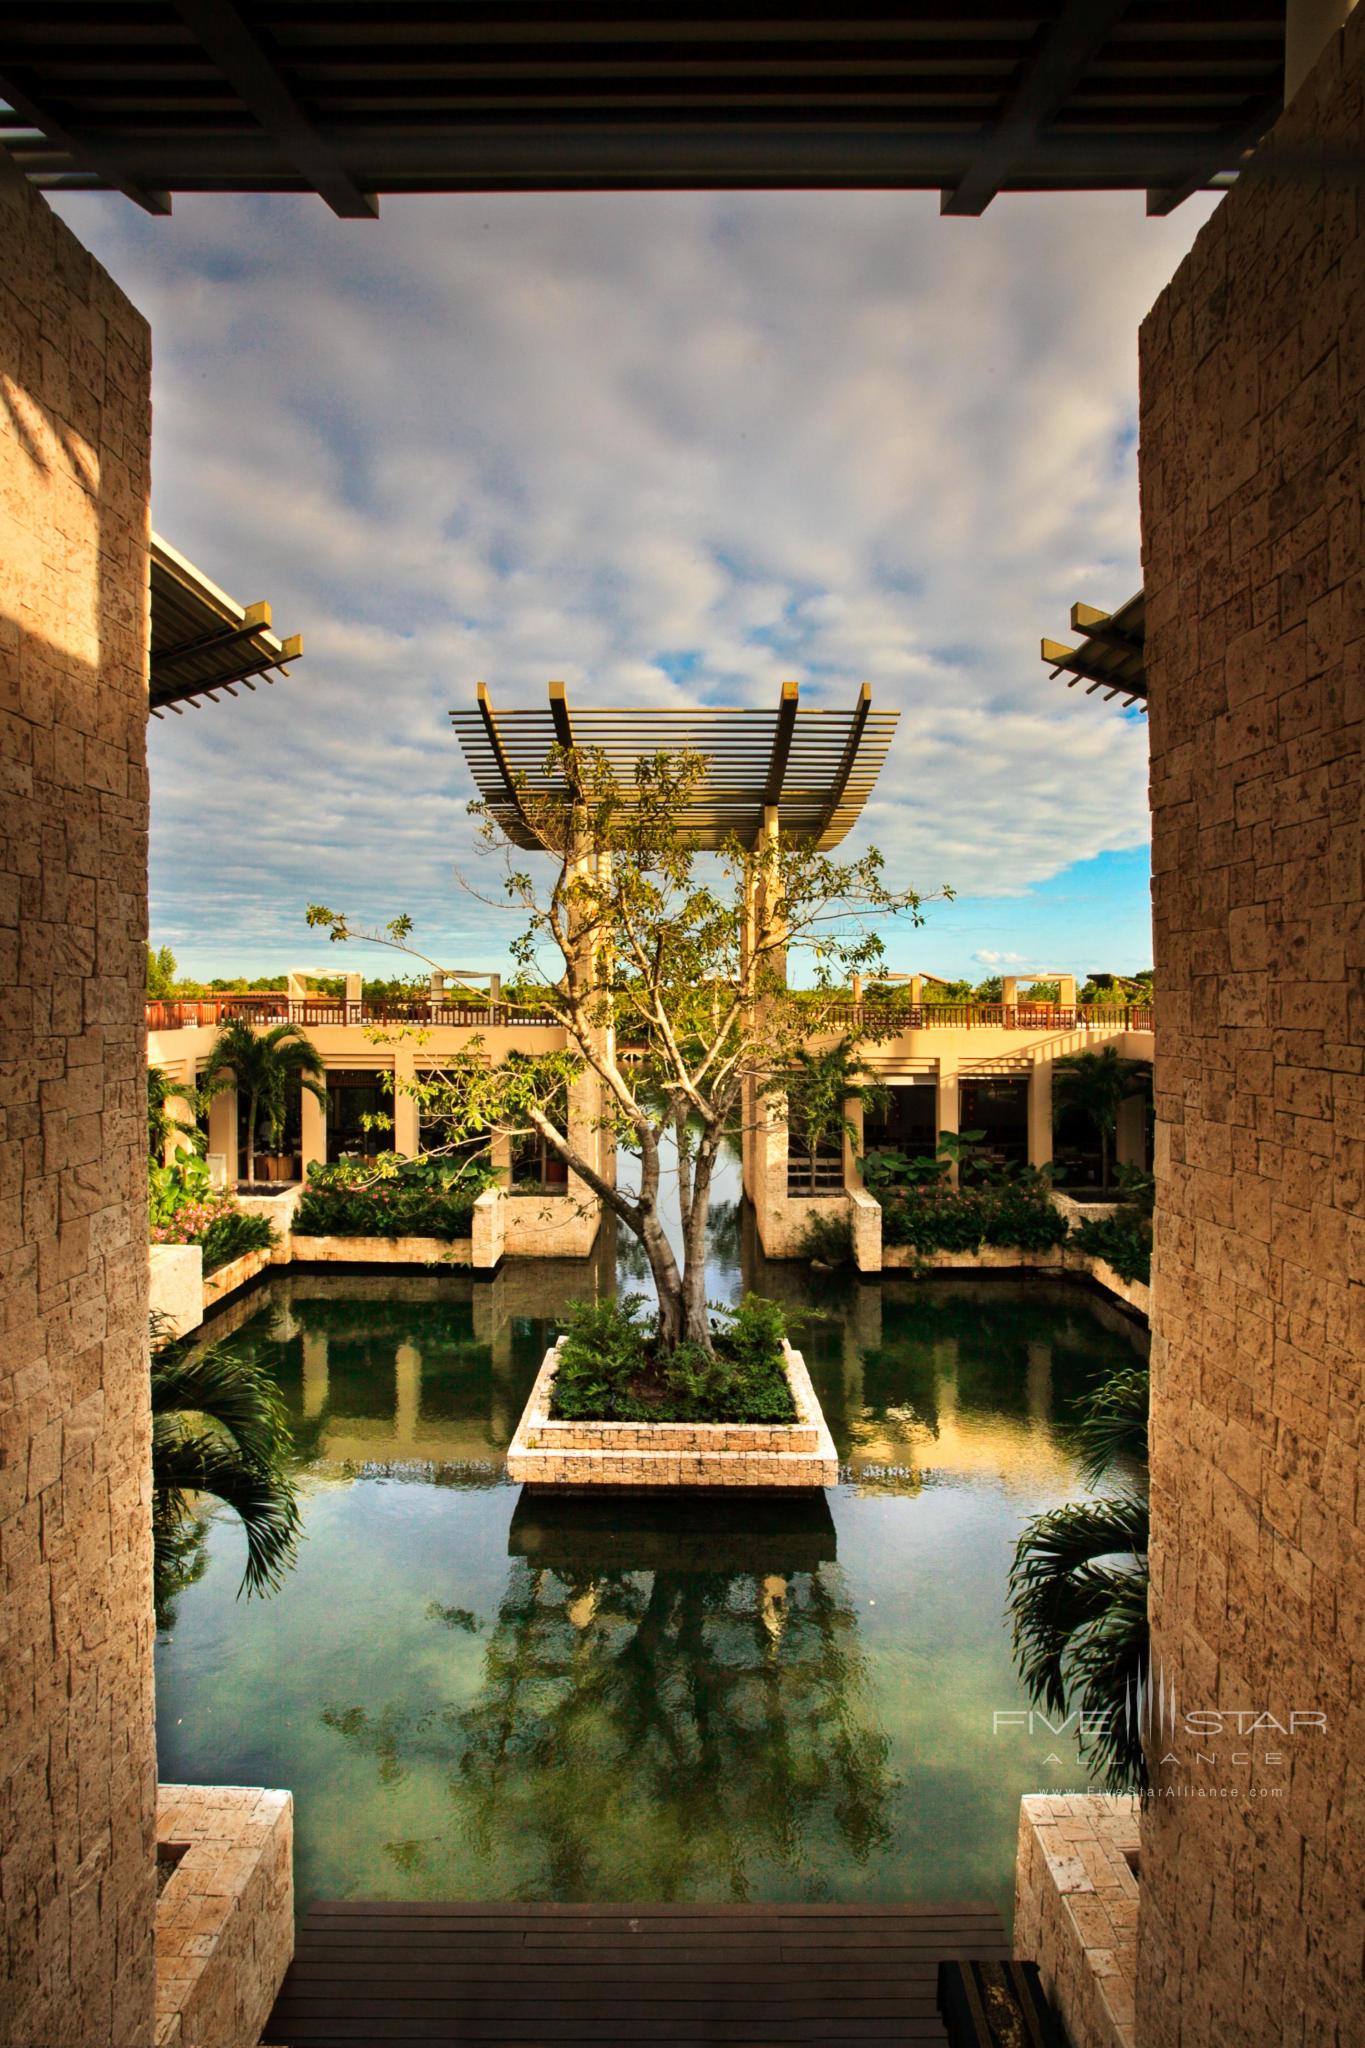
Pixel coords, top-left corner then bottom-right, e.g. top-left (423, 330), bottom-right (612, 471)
top-left (450, 682), bottom-right (900, 848)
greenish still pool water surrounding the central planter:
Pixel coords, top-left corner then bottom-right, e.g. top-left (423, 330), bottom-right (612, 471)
top-left (158, 1233), bottom-right (1146, 1911)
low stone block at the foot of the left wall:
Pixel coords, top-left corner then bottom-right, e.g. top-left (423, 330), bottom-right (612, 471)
top-left (156, 1786), bottom-right (295, 2048)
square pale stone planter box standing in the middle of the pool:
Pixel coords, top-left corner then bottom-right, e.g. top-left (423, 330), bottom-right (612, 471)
top-left (508, 1337), bottom-right (839, 1487)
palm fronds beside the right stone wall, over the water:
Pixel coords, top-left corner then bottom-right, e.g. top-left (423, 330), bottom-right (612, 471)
top-left (1009, 1366), bottom-right (1150, 1792)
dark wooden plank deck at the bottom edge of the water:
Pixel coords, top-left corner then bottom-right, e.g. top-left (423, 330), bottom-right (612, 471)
top-left (262, 1903), bottom-right (1009, 2048)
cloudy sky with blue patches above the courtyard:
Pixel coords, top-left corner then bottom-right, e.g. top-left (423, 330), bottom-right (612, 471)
top-left (59, 193), bottom-right (1216, 979)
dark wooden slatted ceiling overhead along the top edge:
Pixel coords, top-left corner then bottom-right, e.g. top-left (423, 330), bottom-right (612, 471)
top-left (0, 0), bottom-right (1285, 215)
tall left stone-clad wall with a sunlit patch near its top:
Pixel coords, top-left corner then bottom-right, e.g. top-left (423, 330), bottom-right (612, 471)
top-left (0, 160), bottom-right (156, 2048)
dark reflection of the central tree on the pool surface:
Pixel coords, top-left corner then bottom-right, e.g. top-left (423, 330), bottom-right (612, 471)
top-left (323, 1515), bottom-right (896, 1901)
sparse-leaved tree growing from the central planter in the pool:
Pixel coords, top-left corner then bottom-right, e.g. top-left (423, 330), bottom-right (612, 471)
top-left (307, 748), bottom-right (941, 1352)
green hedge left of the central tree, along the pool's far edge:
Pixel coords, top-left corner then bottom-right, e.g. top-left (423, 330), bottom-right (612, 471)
top-left (295, 1153), bottom-right (497, 1239)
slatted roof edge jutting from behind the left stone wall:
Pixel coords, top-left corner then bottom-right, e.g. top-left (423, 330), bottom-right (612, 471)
top-left (147, 532), bottom-right (303, 719)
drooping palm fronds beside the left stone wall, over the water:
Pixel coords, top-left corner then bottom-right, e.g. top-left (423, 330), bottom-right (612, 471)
top-left (151, 1315), bottom-right (299, 1626)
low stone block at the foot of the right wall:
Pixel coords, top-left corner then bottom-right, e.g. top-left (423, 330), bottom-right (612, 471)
top-left (1013, 1792), bottom-right (1138, 2048)
